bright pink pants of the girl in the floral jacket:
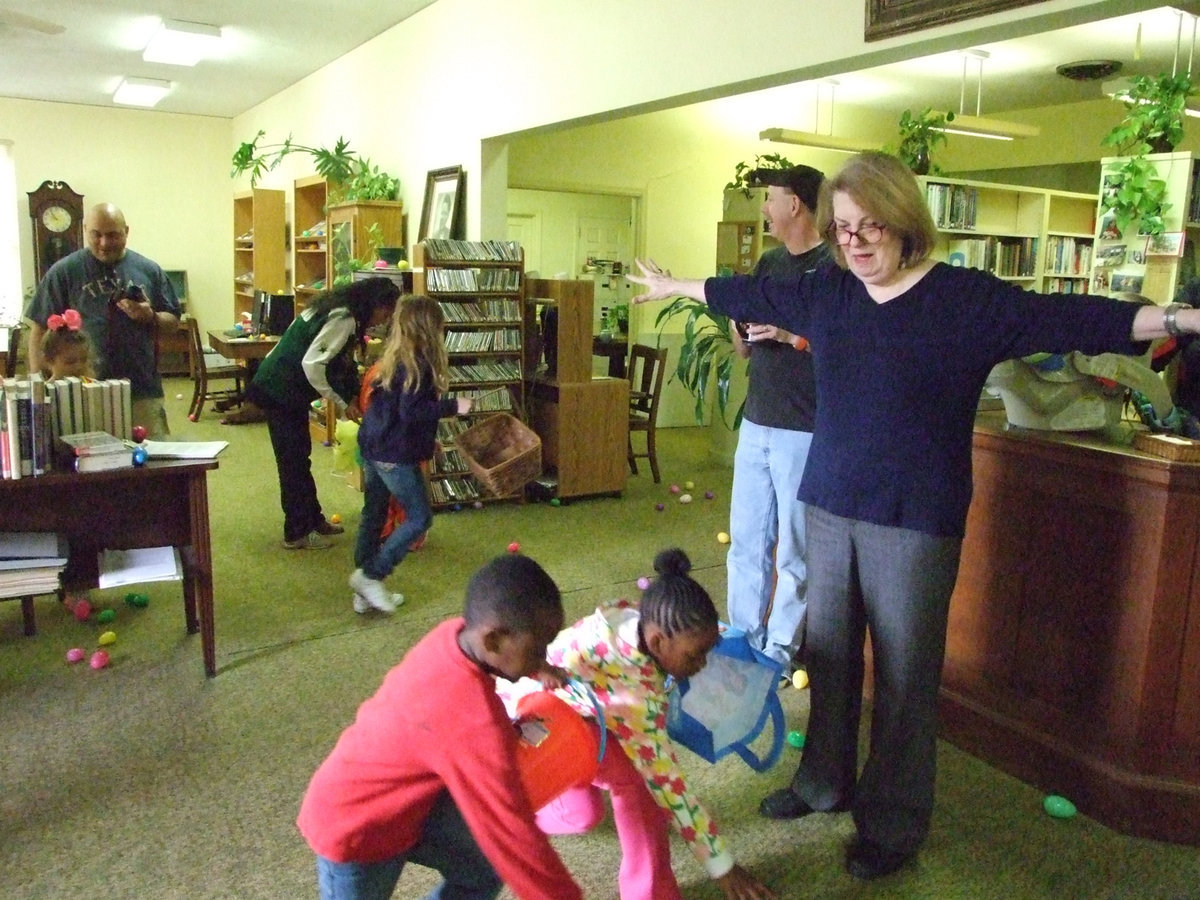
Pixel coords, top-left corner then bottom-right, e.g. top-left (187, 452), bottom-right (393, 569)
top-left (538, 722), bottom-right (683, 900)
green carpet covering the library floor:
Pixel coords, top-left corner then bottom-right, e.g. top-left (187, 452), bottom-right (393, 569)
top-left (0, 380), bottom-right (1200, 900)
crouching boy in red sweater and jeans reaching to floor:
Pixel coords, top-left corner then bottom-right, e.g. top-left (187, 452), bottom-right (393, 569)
top-left (296, 554), bottom-right (583, 900)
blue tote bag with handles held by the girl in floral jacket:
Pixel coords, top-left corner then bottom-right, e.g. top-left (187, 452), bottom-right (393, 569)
top-left (667, 631), bottom-right (784, 772)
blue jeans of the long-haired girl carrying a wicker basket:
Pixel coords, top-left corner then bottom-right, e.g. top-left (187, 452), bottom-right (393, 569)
top-left (354, 460), bottom-right (433, 581)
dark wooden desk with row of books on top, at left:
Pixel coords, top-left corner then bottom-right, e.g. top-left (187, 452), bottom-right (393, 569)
top-left (0, 460), bottom-right (217, 678)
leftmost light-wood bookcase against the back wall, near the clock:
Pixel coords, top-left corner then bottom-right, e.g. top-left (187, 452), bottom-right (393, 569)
top-left (233, 187), bottom-right (288, 320)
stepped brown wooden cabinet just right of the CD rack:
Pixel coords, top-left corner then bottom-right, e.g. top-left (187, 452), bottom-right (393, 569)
top-left (522, 278), bottom-right (629, 497)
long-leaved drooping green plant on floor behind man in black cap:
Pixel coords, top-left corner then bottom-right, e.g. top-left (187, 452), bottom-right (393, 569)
top-left (654, 296), bottom-right (745, 430)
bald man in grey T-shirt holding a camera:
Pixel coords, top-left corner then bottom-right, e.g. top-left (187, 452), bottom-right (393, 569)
top-left (25, 203), bottom-right (179, 438)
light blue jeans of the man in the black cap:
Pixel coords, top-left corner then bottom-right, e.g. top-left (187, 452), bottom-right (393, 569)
top-left (725, 420), bottom-right (812, 672)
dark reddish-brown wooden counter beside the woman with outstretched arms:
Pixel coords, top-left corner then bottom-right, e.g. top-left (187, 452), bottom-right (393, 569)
top-left (941, 413), bottom-right (1200, 844)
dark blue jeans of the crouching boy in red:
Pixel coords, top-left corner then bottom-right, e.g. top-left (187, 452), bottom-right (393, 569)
top-left (317, 791), bottom-right (503, 900)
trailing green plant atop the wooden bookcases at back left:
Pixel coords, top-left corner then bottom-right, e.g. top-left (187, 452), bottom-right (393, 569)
top-left (229, 131), bottom-right (400, 203)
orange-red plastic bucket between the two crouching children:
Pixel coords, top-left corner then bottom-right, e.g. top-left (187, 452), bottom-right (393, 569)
top-left (515, 691), bottom-right (602, 810)
